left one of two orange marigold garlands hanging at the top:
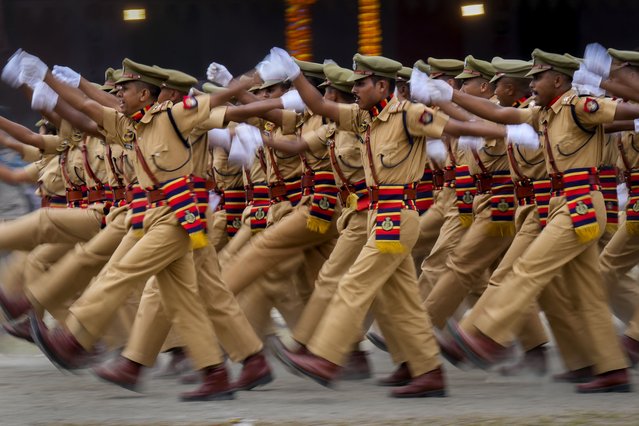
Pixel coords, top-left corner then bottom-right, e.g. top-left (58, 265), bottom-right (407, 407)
top-left (286, 0), bottom-right (315, 61)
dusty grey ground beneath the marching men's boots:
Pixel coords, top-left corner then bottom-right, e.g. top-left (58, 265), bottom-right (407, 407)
top-left (0, 336), bottom-right (639, 425)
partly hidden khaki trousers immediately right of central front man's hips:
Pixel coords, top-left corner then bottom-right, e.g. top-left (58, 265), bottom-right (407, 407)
top-left (417, 188), bottom-right (467, 300)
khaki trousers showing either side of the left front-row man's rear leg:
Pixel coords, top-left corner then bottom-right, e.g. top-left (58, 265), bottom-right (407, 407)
top-left (122, 246), bottom-right (262, 367)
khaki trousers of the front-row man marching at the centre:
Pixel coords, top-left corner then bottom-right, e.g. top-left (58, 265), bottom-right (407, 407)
top-left (308, 210), bottom-right (440, 376)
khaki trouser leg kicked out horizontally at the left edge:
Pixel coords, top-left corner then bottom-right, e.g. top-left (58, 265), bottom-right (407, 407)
top-left (0, 207), bottom-right (104, 250)
